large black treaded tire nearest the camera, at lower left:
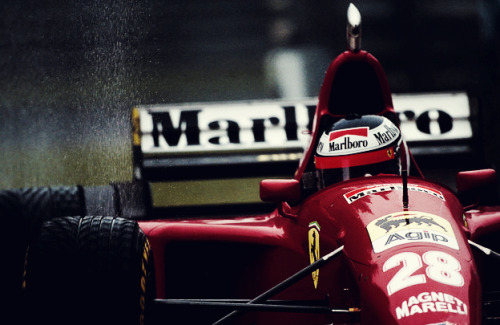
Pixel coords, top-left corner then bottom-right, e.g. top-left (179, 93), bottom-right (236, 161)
top-left (25, 217), bottom-right (154, 325)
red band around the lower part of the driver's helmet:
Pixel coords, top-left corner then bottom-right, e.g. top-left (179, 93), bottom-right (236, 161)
top-left (314, 147), bottom-right (395, 169)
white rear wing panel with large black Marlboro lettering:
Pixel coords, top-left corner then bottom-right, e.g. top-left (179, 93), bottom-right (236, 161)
top-left (137, 93), bottom-right (472, 155)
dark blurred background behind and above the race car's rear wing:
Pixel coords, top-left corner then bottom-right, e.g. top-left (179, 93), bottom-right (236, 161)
top-left (0, 0), bottom-right (500, 188)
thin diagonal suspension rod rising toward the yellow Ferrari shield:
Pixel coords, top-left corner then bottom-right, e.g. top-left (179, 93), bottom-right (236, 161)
top-left (212, 245), bottom-right (344, 325)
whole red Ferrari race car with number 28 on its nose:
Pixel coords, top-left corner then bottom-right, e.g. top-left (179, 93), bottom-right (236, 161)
top-left (5, 6), bottom-right (500, 325)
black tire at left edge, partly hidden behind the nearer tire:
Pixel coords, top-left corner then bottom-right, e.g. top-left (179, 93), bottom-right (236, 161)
top-left (0, 186), bottom-right (85, 318)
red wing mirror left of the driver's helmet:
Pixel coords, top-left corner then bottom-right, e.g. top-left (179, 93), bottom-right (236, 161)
top-left (260, 179), bottom-right (301, 202)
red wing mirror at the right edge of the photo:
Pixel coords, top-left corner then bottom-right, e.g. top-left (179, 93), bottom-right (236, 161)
top-left (457, 169), bottom-right (498, 205)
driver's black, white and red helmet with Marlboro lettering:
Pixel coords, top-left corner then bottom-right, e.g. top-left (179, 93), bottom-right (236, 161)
top-left (314, 115), bottom-right (402, 189)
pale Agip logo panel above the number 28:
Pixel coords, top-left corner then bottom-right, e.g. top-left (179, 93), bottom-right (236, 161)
top-left (366, 211), bottom-right (458, 253)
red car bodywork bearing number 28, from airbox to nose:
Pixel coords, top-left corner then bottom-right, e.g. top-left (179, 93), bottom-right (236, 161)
top-left (136, 51), bottom-right (500, 325)
